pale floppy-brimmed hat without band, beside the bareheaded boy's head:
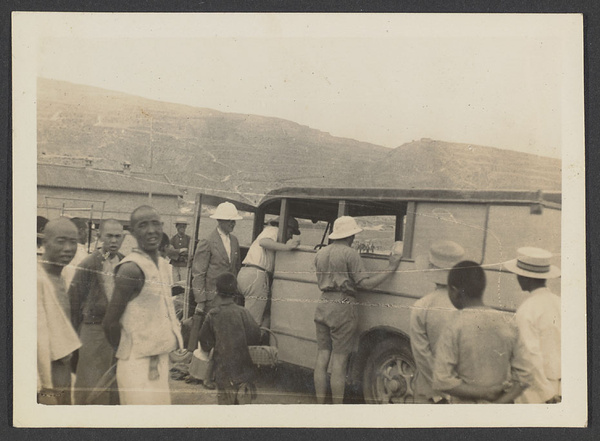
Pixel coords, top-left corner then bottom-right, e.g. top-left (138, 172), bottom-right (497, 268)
top-left (415, 240), bottom-right (465, 285)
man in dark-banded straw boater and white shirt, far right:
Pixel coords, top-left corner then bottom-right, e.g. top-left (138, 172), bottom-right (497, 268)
top-left (504, 247), bottom-right (561, 403)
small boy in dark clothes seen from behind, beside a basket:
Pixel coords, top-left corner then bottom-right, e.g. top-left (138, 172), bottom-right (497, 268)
top-left (199, 273), bottom-right (260, 404)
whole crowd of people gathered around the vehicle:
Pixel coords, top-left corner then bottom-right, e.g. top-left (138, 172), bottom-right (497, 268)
top-left (37, 202), bottom-right (561, 405)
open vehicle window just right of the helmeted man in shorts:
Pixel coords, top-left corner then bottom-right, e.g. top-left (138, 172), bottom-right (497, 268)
top-left (352, 216), bottom-right (396, 256)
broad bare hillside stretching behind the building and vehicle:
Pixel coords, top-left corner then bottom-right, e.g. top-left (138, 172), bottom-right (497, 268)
top-left (37, 78), bottom-right (561, 205)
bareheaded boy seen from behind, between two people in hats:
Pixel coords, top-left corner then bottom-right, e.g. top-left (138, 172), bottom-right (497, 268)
top-left (433, 261), bottom-right (531, 403)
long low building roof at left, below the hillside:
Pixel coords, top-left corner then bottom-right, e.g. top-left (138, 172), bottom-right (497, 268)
top-left (37, 164), bottom-right (182, 196)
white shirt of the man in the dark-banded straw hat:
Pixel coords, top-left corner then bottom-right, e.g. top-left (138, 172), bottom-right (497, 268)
top-left (516, 287), bottom-right (561, 403)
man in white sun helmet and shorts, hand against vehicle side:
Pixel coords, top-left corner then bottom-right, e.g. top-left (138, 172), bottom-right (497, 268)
top-left (314, 216), bottom-right (402, 404)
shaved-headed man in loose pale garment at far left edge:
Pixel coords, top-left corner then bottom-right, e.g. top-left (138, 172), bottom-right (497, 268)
top-left (37, 217), bottom-right (81, 404)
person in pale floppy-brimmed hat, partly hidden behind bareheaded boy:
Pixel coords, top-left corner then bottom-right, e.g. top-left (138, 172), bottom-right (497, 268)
top-left (410, 240), bottom-right (465, 403)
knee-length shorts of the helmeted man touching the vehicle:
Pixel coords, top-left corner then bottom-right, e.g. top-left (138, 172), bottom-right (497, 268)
top-left (315, 292), bottom-right (358, 354)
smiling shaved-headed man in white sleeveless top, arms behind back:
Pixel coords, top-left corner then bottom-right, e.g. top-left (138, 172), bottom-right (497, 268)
top-left (103, 205), bottom-right (183, 404)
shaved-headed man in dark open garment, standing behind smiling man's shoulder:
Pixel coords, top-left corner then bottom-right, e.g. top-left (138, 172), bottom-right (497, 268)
top-left (69, 219), bottom-right (125, 404)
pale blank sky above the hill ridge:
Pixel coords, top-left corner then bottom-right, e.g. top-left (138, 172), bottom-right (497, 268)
top-left (32, 14), bottom-right (577, 157)
